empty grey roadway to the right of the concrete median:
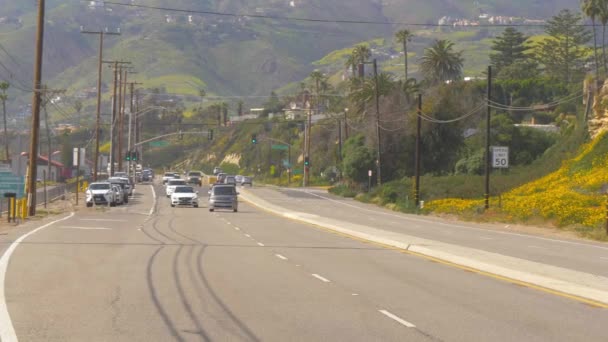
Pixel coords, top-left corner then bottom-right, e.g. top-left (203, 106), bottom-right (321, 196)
top-left (243, 188), bottom-right (608, 276)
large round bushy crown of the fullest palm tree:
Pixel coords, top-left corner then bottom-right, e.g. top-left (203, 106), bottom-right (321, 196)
top-left (420, 39), bottom-right (464, 83)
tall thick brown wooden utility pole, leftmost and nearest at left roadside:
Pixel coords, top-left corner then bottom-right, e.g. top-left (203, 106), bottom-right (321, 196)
top-left (27, 0), bottom-right (45, 216)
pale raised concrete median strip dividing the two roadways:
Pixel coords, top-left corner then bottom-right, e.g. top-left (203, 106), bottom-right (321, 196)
top-left (240, 189), bottom-right (608, 308)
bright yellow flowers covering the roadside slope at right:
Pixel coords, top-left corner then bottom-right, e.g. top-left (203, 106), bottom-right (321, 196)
top-left (425, 134), bottom-right (608, 227)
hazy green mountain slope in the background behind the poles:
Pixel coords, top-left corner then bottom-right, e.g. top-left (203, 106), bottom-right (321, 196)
top-left (0, 0), bottom-right (579, 115)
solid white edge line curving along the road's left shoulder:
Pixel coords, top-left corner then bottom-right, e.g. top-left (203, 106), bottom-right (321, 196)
top-left (0, 213), bottom-right (74, 342)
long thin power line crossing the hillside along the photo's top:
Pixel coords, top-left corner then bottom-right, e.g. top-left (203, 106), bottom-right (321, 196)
top-left (98, 0), bottom-right (564, 27)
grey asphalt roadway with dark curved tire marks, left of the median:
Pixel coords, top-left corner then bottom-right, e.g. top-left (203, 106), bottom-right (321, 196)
top-left (0, 185), bottom-right (608, 341)
